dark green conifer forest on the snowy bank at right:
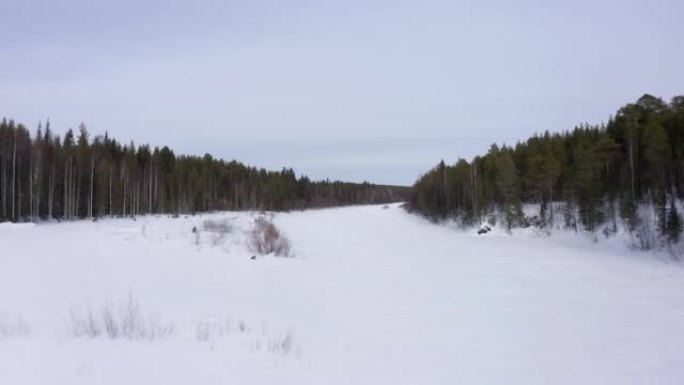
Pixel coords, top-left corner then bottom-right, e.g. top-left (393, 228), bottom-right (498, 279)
top-left (409, 94), bottom-right (684, 249)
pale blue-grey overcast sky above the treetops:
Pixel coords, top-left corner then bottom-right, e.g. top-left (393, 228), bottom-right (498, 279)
top-left (0, 0), bottom-right (684, 185)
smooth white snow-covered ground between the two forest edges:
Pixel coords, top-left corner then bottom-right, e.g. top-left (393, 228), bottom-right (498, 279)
top-left (0, 205), bottom-right (684, 385)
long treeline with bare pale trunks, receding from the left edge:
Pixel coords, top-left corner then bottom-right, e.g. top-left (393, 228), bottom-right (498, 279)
top-left (0, 119), bottom-right (409, 222)
